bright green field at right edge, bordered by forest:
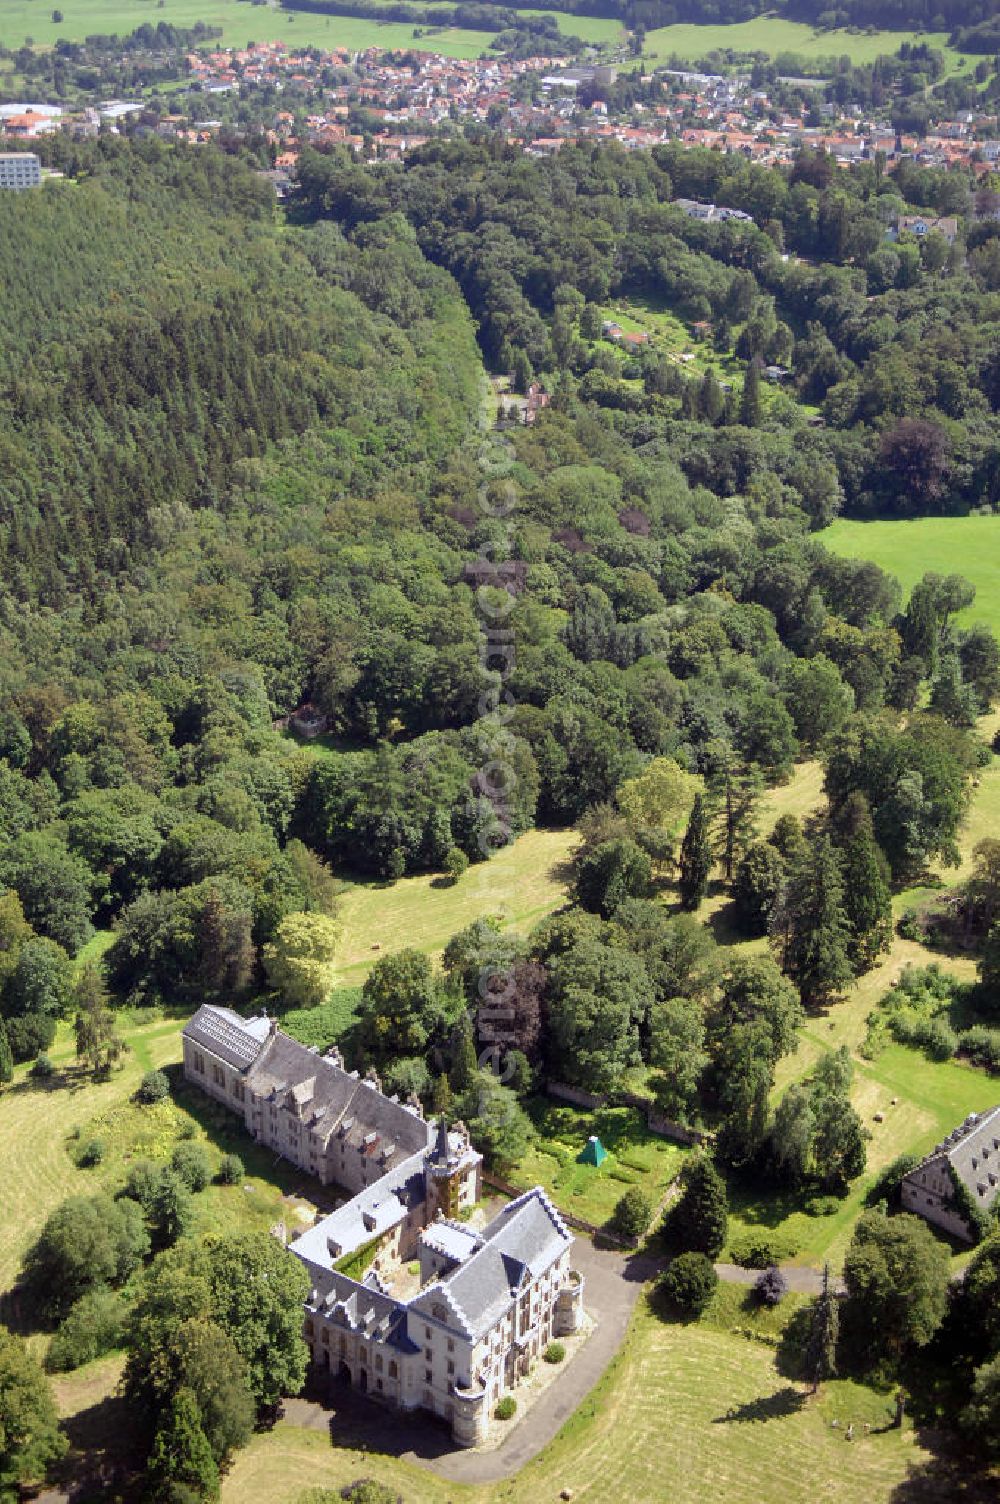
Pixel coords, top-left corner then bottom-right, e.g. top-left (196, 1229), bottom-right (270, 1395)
top-left (818, 517), bottom-right (1000, 633)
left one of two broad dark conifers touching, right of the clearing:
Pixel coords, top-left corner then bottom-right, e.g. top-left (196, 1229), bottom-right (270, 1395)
top-left (785, 836), bottom-right (854, 1008)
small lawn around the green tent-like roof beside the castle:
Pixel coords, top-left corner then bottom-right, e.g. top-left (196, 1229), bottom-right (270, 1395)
top-left (508, 1098), bottom-right (687, 1227)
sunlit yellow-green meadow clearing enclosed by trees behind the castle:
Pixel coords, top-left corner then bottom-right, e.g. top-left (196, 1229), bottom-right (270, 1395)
top-left (337, 830), bottom-right (577, 984)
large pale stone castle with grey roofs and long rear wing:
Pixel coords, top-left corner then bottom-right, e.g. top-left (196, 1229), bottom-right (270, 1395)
top-left (183, 1005), bottom-right (583, 1447)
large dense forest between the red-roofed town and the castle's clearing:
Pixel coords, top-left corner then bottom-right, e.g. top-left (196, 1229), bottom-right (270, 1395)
top-left (0, 140), bottom-right (1000, 1069)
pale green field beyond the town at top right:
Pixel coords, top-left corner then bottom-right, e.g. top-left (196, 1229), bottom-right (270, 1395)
top-left (642, 17), bottom-right (968, 71)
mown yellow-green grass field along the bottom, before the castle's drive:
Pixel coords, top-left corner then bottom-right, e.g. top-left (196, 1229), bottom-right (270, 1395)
top-left (223, 1292), bottom-right (944, 1504)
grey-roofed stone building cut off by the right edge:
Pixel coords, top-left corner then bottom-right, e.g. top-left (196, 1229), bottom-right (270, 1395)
top-left (902, 1107), bottom-right (1000, 1242)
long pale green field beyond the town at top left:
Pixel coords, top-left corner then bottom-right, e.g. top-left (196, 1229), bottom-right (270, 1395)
top-left (0, 0), bottom-right (621, 57)
